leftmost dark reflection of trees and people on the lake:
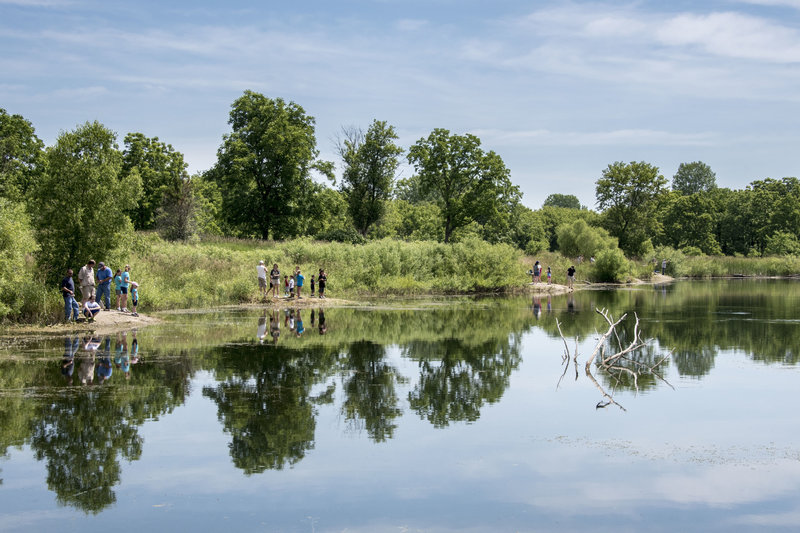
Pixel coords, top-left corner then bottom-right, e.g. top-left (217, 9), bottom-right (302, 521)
top-left (0, 337), bottom-right (191, 513)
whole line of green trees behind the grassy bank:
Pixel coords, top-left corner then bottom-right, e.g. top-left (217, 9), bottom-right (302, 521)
top-left (0, 91), bottom-right (800, 317)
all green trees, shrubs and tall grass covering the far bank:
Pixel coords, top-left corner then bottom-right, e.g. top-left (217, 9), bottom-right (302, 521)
top-left (0, 91), bottom-right (800, 322)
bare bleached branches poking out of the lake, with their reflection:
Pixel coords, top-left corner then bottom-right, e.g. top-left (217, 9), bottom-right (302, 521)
top-left (556, 309), bottom-right (674, 411)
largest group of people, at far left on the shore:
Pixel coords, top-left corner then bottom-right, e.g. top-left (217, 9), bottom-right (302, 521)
top-left (61, 259), bottom-right (139, 322)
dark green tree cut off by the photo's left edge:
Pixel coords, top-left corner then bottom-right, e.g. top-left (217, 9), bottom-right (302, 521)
top-left (0, 108), bottom-right (44, 202)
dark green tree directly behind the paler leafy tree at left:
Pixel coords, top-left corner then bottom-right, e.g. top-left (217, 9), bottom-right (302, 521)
top-left (120, 133), bottom-right (187, 229)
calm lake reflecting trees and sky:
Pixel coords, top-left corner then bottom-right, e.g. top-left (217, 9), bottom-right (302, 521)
top-left (0, 280), bottom-right (800, 532)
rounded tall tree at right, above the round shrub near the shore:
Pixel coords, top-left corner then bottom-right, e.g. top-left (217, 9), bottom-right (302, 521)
top-left (595, 161), bottom-right (667, 255)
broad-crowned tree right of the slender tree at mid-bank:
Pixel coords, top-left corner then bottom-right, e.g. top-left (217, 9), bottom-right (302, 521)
top-left (408, 128), bottom-right (520, 242)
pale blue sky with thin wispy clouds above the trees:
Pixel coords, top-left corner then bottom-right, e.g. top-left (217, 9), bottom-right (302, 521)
top-left (0, 0), bottom-right (800, 209)
